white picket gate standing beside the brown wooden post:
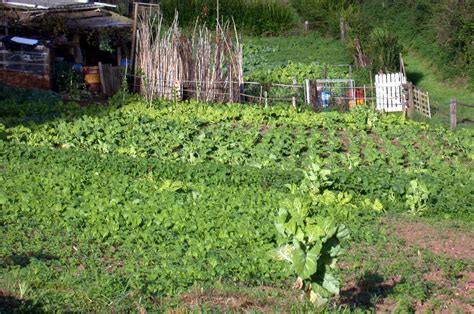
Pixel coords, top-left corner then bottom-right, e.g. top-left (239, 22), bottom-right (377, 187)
top-left (375, 73), bottom-right (407, 112)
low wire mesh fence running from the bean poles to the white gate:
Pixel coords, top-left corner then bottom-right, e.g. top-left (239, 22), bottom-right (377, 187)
top-left (123, 75), bottom-right (414, 112)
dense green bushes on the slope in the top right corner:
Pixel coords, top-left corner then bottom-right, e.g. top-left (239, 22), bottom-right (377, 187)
top-left (361, 0), bottom-right (474, 87)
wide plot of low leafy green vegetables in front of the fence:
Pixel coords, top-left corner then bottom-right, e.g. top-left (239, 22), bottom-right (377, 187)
top-left (0, 94), bottom-right (474, 311)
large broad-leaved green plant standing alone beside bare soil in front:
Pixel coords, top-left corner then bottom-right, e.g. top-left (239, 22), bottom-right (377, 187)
top-left (275, 199), bottom-right (349, 305)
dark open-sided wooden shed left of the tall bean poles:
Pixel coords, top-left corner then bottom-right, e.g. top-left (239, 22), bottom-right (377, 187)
top-left (0, 0), bottom-right (132, 93)
